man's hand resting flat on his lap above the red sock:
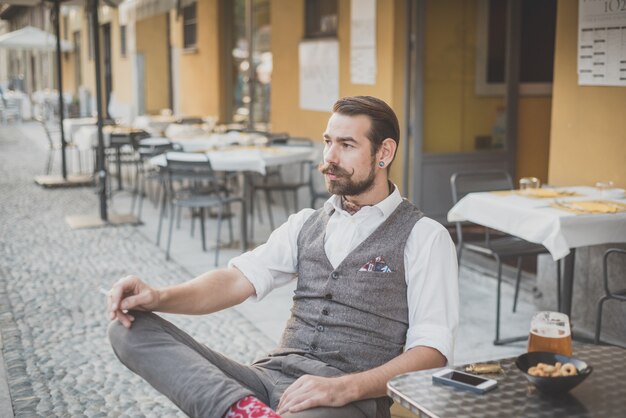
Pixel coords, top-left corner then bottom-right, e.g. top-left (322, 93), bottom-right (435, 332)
top-left (276, 375), bottom-right (356, 414)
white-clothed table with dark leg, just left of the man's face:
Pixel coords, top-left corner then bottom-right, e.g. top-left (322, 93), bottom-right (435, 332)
top-left (149, 146), bottom-right (315, 251)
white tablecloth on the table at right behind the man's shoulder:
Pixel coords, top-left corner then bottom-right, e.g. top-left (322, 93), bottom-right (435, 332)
top-left (448, 186), bottom-right (626, 260)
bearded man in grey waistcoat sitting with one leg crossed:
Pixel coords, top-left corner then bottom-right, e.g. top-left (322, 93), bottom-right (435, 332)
top-left (108, 96), bottom-right (458, 418)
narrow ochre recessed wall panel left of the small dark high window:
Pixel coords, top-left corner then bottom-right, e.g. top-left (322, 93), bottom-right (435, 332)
top-left (135, 13), bottom-right (170, 114)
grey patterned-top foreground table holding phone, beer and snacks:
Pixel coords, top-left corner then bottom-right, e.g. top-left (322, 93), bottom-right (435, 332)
top-left (387, 344), bottom-right (626, 418)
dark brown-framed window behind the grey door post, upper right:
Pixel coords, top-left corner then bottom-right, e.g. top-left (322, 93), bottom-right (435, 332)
top-left (476, 0), bottom-right (556, 95)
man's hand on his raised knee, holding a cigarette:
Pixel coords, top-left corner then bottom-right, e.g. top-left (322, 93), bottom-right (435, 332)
top-left (107, 276), bottom-right (159, 328)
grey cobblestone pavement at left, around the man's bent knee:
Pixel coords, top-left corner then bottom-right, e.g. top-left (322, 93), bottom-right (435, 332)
top-left (0, 122), bottom-right (271, 417)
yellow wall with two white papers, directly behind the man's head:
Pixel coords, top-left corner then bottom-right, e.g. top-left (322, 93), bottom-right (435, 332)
top-left (270, 0), bottom-right (404, 182)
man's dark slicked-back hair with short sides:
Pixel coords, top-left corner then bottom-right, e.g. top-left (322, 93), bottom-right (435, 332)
top-left (333, 96), bottom-right (400, 158)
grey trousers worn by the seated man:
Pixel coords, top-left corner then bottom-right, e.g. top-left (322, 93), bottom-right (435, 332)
top-left (109, 311), bottom-right (389, 418)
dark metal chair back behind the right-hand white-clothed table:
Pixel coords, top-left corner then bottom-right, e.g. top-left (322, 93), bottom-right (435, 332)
top-left (450, 170), bottom-right (513, 204)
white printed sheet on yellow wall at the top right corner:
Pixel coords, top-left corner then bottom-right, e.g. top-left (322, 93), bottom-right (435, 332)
top-left (578, 0), bottom-right (626, 86)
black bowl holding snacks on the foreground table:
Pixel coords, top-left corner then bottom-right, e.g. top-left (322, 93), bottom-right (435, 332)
top-left (515, 351), bottom-right (593, 394)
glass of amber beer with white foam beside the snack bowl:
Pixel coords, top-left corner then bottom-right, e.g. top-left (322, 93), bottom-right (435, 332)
top-left (528, 312), bottom-right (572, 356)
